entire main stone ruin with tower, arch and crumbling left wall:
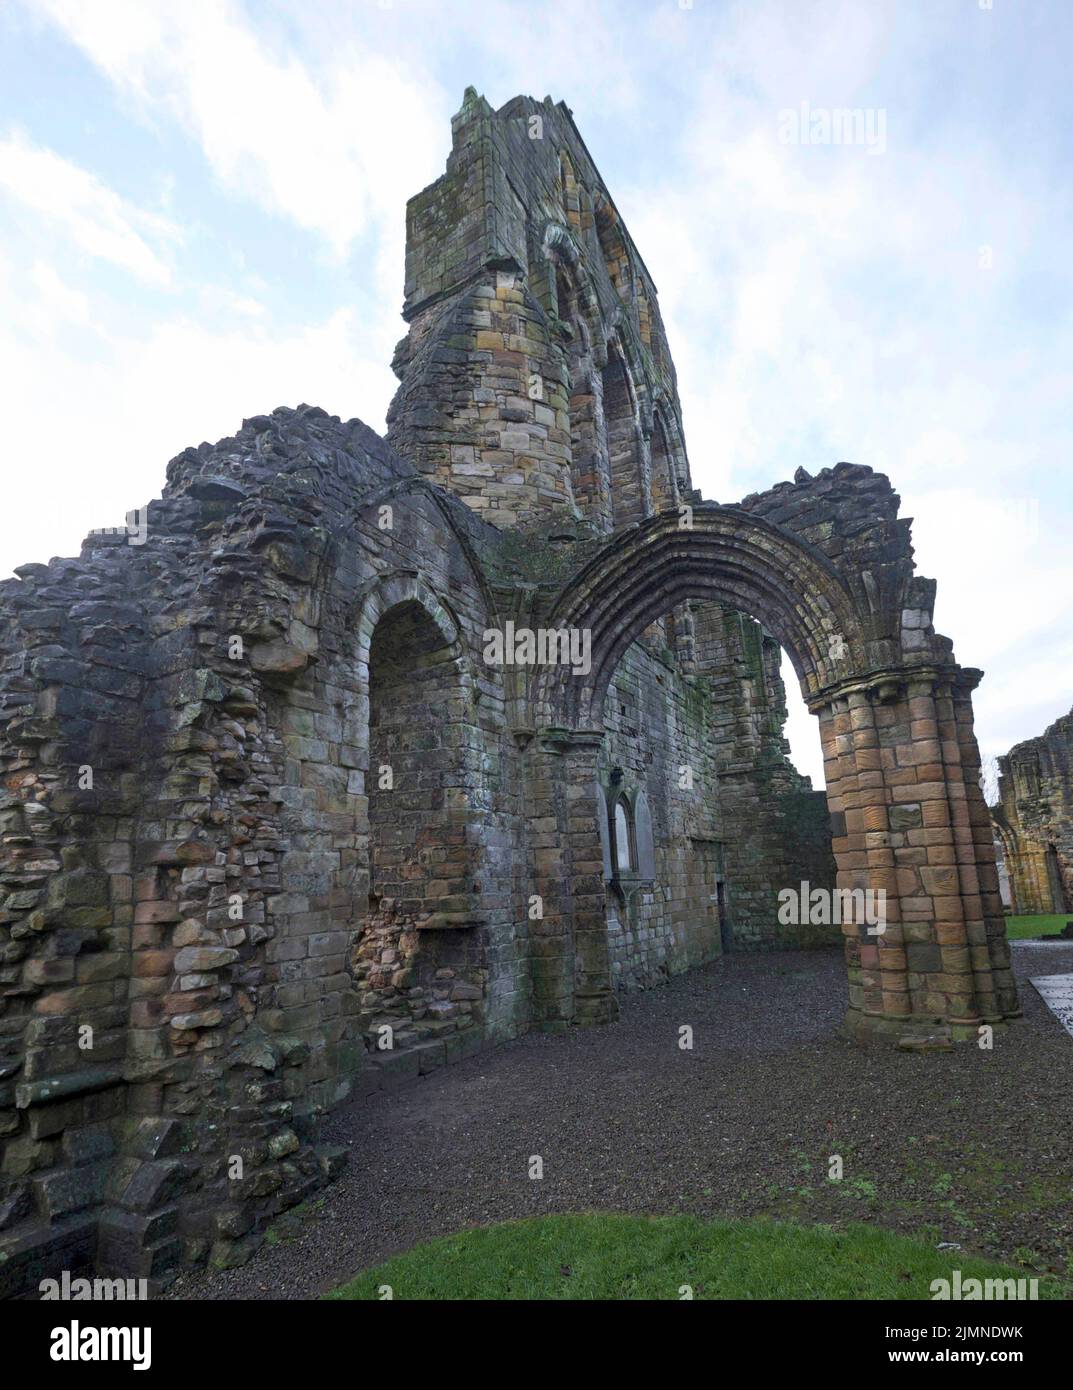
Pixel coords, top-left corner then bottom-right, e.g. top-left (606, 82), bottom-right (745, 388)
top-left (0, 89), bottom-right (1017, 1294)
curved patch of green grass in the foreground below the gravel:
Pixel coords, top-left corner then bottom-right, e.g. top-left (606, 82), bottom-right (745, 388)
top-left (325, 1212), bottom-right (1063, 1300)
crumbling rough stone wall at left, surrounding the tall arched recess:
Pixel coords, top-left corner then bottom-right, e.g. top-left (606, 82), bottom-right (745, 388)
top-left (0, 407), bottom-right (525, 1287)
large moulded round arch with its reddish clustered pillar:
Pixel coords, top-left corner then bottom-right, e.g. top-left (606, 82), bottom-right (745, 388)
top-left (537, 505), bottom-right (1019, 1037)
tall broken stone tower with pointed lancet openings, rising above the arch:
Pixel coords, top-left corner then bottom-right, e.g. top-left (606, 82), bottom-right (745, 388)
top-left (388, 88), bottom-right (691, 532)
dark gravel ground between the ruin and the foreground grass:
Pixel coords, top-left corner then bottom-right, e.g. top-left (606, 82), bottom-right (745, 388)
top-left (167, 945), bottom-right (1073, 1298)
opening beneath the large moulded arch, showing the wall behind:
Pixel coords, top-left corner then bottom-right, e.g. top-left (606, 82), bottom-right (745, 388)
top-left (600, 599), bottom-right (842, 988)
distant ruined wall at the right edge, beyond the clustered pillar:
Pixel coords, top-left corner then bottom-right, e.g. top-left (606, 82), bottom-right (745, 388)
top-left (991, 713), bottom-right (1073, 913)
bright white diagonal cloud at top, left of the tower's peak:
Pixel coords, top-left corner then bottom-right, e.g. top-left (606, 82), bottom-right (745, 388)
top-left (40, 0), bottom-right (449, 259)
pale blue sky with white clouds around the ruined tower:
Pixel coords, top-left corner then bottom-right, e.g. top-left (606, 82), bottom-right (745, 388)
top-left (0, 0), bottom-right (1073, 785)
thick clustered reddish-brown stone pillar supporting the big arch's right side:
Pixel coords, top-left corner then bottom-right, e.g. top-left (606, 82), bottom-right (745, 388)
top-left (814, 670), bottom-right (1017, 1037)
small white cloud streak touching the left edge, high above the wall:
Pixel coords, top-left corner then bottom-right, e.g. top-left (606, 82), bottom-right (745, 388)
top-left (0, 131), bottom-right (181, 285)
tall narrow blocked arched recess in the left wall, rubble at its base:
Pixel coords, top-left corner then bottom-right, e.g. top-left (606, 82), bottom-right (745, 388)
top-left (350, 574), bottom-right (484, 1055)
